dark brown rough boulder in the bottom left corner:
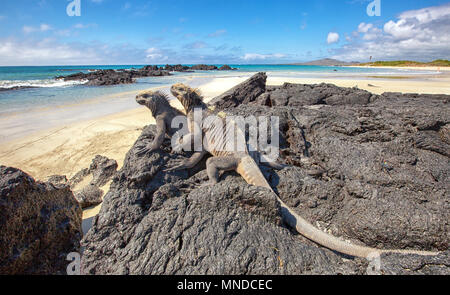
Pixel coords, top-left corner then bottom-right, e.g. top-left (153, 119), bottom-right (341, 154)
top-left (0, 166), bottom-right (82, 274)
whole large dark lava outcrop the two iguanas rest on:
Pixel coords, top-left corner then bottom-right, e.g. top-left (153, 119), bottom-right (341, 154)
top-left (82, 74), bottom-right (450, 274)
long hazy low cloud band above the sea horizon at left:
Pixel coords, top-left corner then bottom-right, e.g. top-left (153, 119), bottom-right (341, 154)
top-left (0, 36), bottom-right (246, 66)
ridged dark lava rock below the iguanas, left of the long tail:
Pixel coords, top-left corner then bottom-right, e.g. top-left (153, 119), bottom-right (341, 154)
top-left (82, 126), bottom-right (360, 274)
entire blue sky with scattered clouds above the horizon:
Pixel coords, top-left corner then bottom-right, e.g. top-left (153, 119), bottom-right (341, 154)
top-left (0, 0), bottom-right (450, 65)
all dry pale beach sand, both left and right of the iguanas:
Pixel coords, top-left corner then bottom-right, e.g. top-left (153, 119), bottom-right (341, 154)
top-left (0, 71), bottom-right (450, 218)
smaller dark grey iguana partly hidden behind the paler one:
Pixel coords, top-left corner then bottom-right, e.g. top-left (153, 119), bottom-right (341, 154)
top-left (136, 90), bottom-right (187, 156)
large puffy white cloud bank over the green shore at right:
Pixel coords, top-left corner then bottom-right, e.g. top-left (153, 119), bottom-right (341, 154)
top-left (333, 3), bottom-right (450, 61)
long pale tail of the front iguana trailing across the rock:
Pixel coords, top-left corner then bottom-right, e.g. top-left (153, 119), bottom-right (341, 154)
top-left (236, 156), bottom-right (439, 258)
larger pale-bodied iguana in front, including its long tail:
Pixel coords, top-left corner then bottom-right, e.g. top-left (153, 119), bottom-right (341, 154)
top-left (170, 84), bottom-right (439, 260)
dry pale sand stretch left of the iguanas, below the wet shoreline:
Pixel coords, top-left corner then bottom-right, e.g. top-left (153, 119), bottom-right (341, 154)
top-left (0, 108), bottom-right (154, 180)
